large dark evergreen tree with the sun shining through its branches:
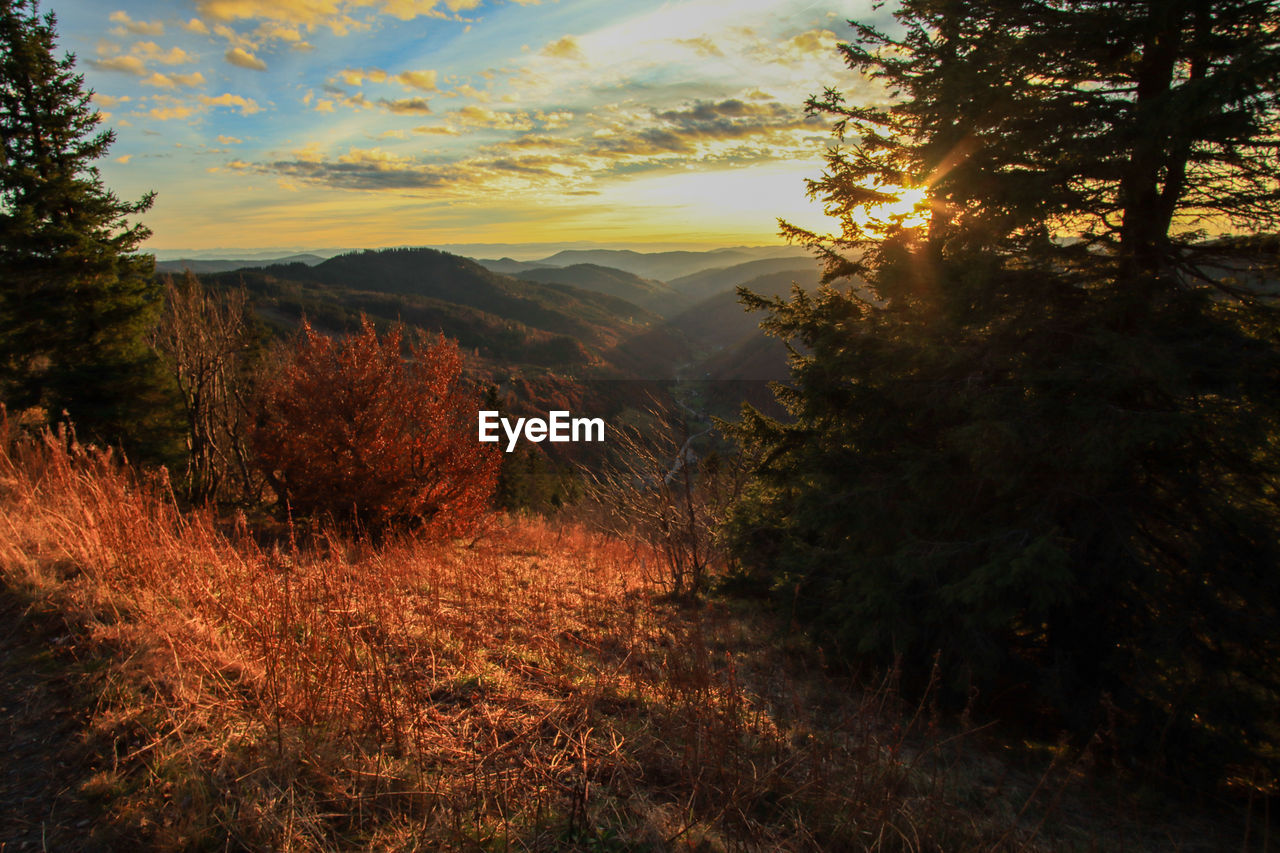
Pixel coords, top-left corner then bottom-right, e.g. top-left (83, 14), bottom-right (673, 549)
top-left (731, 0), bottom-right (1280, 761)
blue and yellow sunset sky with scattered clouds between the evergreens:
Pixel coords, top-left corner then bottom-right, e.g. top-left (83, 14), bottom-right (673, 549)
top-left (41, 0), bottom-right (887, 254)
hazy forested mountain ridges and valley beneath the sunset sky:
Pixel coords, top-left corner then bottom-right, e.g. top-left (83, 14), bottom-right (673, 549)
top-left (175, 247), bottom-right (818, 412)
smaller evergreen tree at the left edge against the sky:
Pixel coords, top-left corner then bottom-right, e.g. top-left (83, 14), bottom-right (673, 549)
top-left (0, 0), bottom-right (172, 452)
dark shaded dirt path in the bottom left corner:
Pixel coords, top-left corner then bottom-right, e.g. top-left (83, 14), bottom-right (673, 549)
top-left (0, 585), bottom-right (92, 853)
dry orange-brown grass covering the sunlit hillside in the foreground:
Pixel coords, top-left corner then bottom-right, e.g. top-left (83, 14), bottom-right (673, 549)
top-left (0, 422), bottom-right (1239, 850)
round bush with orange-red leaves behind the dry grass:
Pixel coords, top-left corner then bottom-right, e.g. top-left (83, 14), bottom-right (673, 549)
top-left (252, 319), bottom-right (499, 535)
